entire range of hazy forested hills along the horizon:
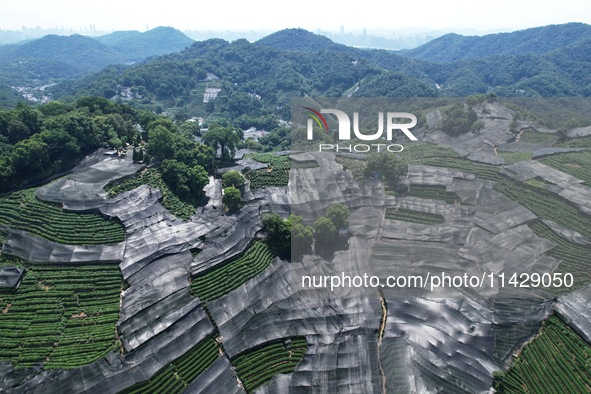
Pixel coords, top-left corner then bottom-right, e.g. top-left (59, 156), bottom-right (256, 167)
top-left (0, 23), bottom-right (591, 111)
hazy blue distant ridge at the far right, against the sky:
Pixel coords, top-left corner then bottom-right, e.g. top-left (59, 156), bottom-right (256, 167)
top-left (403, 23), bottom-right (591, 62)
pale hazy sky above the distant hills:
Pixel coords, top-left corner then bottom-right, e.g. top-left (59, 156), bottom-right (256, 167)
top-left (0, 0), bottom-right (591, 31)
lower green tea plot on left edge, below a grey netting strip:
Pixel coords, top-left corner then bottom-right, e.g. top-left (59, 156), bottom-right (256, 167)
top-left (0, 257), bottom-right (123, 369)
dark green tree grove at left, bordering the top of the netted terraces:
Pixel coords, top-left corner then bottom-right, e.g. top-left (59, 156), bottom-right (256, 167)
top-left (0, 97), bottom-right (219, 201)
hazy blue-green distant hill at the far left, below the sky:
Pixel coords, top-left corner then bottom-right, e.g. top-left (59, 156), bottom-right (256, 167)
top-left (0, 28), bottom-right (193, 86)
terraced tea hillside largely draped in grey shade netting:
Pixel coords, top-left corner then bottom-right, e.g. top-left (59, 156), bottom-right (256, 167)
top-left (5, 97), bottom-right (591, 394)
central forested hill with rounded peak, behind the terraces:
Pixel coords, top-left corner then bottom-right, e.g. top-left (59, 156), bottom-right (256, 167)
top-left (56, 35), bottom-right (437, 117)
